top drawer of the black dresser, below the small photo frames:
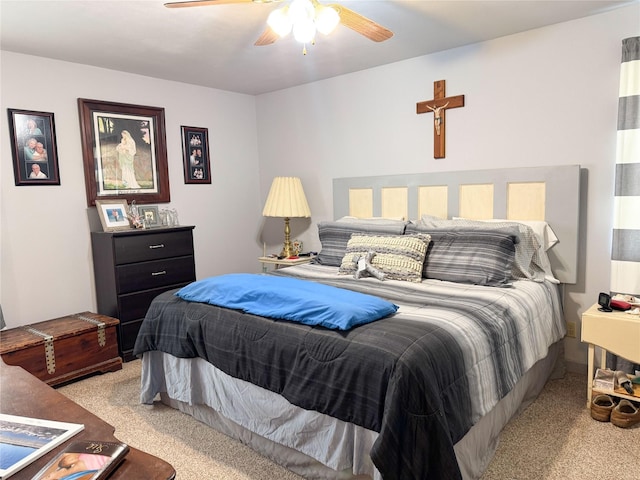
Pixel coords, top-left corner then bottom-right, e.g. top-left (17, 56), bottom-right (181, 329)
top-left (113, 230), bottom-right (193, 265)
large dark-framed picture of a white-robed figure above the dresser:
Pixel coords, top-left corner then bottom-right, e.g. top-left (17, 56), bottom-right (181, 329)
top-left (78, 98), bottom-right (171, 206)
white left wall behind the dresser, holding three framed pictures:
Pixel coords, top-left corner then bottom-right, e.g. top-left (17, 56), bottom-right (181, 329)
top-left (0, 51), bottom-right (262, 327)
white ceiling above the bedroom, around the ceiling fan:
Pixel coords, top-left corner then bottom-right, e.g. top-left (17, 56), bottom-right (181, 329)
top-left (0, 0), bottom-right (640, 95)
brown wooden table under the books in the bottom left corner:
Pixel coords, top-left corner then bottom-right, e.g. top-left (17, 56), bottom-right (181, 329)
top-left (0, 361), bottom-right (176, 480)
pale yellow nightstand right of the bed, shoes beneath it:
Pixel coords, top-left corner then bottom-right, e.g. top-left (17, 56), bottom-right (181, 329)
top-left (581, 304), bottom-right (640, 408)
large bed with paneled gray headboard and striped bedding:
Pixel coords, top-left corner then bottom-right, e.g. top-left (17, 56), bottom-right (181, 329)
top-left (135, 166), bottom-right (580, 479)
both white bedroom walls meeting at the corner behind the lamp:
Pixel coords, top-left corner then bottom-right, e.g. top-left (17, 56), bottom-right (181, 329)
top-left (0, 5), bottom-right (640, 364)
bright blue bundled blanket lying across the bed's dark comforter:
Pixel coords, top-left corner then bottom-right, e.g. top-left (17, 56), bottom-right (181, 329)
top-left (176, 273), bottom-right (398, 330)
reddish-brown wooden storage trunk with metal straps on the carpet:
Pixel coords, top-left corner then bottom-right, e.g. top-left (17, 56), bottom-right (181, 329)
top-left (0, 312), bottom-right (122, 385)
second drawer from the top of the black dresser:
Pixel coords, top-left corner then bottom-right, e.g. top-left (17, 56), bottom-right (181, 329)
top-left (116, 255), bottom-right (196, 295)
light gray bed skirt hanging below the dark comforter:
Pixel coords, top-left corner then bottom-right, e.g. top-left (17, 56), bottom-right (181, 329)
top-left (141, 340), bottom-right (563, 480)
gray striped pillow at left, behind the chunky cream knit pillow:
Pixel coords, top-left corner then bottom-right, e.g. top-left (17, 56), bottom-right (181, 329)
top-left (315, 221), bottom-right (406, 267)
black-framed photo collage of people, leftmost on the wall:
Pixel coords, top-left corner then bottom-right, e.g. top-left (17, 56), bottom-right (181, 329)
top-left (7, 108), bottom-right (60, 185)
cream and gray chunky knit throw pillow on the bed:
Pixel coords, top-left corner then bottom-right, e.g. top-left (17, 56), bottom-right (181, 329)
top-left (339, 234), bottom-right (431, 282)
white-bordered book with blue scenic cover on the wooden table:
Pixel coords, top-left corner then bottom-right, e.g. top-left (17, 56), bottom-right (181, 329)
top-left (0, 413), bottom-right (84, 480)
